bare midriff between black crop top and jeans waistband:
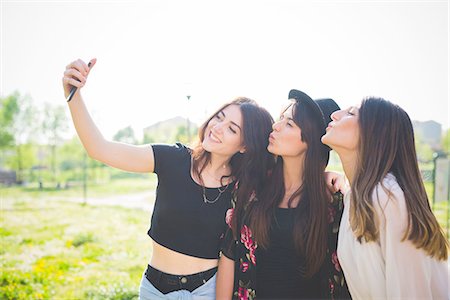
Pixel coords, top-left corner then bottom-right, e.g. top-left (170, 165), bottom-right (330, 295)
top-left (150, 241), bottom-right (219, 275)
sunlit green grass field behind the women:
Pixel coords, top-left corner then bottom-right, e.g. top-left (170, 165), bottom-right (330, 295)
top-left (0, 178), bottom-right (447, 299)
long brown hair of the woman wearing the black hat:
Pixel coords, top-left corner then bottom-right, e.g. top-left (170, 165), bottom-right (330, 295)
top-left (249, 101), bottom-right (331, 277)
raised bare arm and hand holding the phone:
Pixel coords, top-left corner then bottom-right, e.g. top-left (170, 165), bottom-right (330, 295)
top-left (62, 59), bottom-right (154, 173)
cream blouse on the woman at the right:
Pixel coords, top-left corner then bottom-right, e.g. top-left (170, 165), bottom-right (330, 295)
top-left (337, 174), bottom-right (450, 300)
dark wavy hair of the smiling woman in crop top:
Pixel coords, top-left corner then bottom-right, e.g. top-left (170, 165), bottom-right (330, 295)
top-left (192, 97), bottom-right (274, 205)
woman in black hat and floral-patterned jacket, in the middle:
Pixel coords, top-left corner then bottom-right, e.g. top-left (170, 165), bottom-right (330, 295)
top-left (217, 90), bottom-right (348, 299)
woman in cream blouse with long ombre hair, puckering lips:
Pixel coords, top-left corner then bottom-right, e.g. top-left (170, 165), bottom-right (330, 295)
top-left (322, 98), bottom-right (450, 299)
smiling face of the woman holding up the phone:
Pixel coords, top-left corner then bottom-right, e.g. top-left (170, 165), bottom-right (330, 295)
top-left (202, 104), bottom-right (244, 156)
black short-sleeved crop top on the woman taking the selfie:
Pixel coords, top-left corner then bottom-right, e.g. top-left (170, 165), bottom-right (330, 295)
top-left (148, 143), bottom-right (234, 259)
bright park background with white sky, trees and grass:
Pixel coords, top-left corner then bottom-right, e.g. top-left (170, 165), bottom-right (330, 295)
top-left (0, 0), bottom-right (450, 299)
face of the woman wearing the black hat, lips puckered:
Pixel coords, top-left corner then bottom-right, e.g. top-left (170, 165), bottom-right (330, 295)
top-left (267, 104), bottom-right (307, 156)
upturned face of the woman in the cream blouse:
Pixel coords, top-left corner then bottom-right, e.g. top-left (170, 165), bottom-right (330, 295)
top-left (322, 106), bottom-right (360, 153)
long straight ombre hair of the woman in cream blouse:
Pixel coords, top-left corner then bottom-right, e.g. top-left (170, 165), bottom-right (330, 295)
top-left (350, 97), bottom-right (449, 260)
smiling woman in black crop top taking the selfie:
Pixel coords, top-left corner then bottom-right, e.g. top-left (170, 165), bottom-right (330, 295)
top-left (63, 59), bottom-right (274, 299)
